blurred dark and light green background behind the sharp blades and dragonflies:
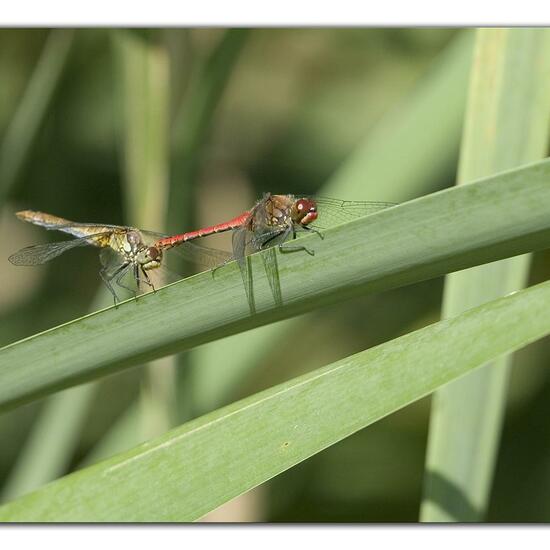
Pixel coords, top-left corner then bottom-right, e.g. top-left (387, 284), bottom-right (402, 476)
top-left (0, 28), bottom-right (550, 522)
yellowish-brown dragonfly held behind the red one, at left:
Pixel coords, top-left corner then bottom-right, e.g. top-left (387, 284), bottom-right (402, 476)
top-left (8, 210), bottom-right (231, 306)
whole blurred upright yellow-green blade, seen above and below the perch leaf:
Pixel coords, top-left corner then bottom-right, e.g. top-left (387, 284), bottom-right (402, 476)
top-left (113, 29), bottom-right (176, 438)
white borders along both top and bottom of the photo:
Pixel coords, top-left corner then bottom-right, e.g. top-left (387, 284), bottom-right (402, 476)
top-left (0, 0), bottom-right (550, 550)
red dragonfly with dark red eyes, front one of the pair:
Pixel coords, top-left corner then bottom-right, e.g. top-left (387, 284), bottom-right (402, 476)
top-left (157, 193), bottom-right (396, 309)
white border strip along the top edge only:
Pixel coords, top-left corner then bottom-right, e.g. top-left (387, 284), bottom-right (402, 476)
top-left (0, 0), bottom-right (550, 27)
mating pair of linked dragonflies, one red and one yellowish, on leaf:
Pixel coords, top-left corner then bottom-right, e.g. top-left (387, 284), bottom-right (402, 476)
top-left (9, 194), bottom-right (394, 306)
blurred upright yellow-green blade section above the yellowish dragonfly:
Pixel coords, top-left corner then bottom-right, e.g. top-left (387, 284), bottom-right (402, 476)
top-left (113, 30), bottom-right (170, 231)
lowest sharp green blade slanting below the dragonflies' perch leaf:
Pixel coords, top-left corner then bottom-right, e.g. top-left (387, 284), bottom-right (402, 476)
top-left (0, 282), bottom-right (550, 522)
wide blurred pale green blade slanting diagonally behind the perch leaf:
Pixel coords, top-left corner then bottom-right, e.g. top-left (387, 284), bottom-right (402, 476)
top-left (193, 31), bottom-right (473, 412)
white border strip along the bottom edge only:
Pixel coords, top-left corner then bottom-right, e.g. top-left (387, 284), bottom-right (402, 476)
top-left (0, 524), bottom-right (548, 550)
